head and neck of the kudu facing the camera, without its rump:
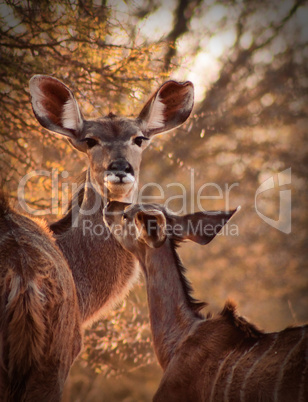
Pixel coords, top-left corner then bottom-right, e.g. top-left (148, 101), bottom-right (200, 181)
top-left (30, 75), bottom-right (194, 324)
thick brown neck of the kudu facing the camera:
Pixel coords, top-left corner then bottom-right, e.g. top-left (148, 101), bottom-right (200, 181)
top-left (51, 172), bottom-right (139, 322)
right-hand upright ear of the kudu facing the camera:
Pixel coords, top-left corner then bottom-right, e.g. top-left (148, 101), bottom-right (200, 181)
top-left (137, 81), bottom-right (194, 137)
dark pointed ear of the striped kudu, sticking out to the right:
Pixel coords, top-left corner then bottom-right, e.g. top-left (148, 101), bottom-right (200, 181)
top-left (167, 207), bottom-right (240, 245)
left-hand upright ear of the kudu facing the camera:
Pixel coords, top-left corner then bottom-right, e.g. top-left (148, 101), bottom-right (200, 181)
top-left (30, 75), bottom-right (87, 151)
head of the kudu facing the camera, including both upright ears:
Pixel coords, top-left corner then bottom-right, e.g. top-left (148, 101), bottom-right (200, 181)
top-left (30, 75), bottom-right (194, 202)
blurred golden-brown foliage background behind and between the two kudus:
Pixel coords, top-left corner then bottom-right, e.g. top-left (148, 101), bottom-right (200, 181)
top-left (0, 0), bottom-right (308, 402)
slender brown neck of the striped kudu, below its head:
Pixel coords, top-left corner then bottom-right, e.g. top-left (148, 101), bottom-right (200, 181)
top-left (141, 239), bottom-right (203, 369)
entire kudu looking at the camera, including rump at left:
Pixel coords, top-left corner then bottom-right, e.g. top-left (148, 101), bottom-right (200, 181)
top-left (0, 75), bottom-right (193, 401)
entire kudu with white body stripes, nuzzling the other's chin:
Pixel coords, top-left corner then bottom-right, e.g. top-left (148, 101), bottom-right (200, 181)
top-left (105, 202), bottom-right (308, 402)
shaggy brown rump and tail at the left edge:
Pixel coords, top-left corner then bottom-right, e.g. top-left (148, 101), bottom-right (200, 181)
top-left (0, 194), bottom-right (82, 402)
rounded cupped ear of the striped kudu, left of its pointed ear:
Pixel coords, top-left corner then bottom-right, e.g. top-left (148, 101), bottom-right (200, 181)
top-left (134, 210), bottom-right (167, 248)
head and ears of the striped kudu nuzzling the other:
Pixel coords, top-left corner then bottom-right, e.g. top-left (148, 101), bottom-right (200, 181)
top-left (104, 201), bottom-right (239, 261)
